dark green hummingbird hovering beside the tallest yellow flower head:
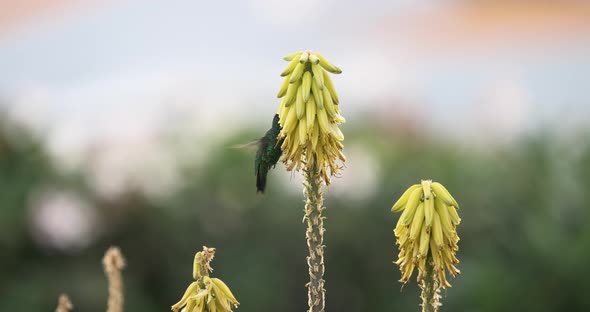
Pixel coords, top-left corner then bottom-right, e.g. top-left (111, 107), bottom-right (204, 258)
top-left (254, 114), bottom-right (284, 193)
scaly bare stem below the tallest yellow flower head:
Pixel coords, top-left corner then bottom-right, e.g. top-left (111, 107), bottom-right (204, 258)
top-left (303, 162), bottom-right (326, 312)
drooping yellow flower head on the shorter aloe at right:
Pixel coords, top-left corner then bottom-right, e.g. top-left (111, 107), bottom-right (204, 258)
top-left (391, 180), bottom-right (461, 288)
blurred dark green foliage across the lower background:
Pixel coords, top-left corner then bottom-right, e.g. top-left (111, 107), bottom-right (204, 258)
top-left (0, 116), bottom-right (590, 311)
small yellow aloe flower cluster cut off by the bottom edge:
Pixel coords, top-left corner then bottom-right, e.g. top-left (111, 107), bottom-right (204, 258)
top-left (172, 246), bottom-right (240, 312)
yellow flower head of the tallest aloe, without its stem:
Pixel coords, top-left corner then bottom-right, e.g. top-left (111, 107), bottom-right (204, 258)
top-left (278, 52), bottom-right (346, 184)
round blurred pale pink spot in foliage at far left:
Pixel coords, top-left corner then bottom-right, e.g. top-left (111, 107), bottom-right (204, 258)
top-left (30, 192), bottom-right (97, 250)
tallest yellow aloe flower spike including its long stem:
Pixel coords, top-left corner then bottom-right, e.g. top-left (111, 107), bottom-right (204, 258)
top-left (278, 51), bottom-right (346, 312)
